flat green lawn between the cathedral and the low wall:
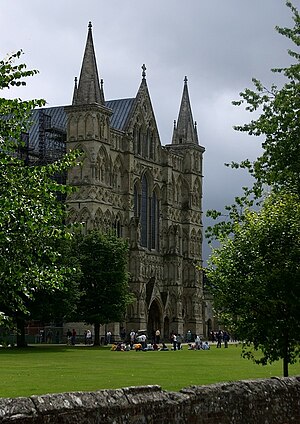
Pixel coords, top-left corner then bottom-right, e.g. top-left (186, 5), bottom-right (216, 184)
top-left (0, 345), bottom-right (300, 397)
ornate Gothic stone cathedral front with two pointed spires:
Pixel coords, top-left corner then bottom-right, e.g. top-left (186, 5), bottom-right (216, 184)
top-left (65, 24), bottom-right (204, 338)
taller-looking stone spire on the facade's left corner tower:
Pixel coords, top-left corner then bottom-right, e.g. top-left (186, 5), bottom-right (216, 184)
top-left (73, 22), bottom-right (105, 106)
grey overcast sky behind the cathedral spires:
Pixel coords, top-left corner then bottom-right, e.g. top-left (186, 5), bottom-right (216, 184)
top-left (0, 0), bottom-right (300, 258)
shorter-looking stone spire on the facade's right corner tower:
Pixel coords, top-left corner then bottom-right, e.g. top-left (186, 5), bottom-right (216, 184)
top-left (172, 77), bottom-right (199, 144)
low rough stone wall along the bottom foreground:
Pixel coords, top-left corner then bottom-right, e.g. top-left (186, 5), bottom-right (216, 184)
top-left (0, 377), bottom-right (300, 424)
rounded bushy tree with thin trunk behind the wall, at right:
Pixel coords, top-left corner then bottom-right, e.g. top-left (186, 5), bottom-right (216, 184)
top-left (207, 193), bottom-right (300, 376)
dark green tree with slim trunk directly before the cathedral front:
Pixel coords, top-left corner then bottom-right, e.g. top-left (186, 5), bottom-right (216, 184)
top-left (74, 230), bottom-right (131, 345)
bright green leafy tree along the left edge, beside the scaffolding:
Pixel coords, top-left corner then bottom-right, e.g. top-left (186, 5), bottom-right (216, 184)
top-left (0, 51), bottom-right (77, 342)
